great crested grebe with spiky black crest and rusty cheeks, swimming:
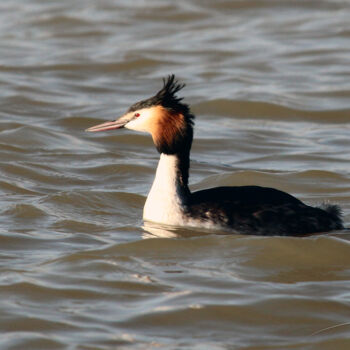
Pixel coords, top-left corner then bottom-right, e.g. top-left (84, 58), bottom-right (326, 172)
top-left (87, 75), bottom-right (343, 236)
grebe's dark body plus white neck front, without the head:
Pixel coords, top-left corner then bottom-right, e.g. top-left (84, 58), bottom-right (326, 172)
top-left (143, 154), bottom-right (342, 236)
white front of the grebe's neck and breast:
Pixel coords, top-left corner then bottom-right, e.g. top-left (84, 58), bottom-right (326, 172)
top-left (143, 153), bottom-right (189, 225)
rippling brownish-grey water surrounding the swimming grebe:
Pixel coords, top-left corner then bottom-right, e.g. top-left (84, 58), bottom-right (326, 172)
top-left (0, 0), bottom-right (350, 350)
